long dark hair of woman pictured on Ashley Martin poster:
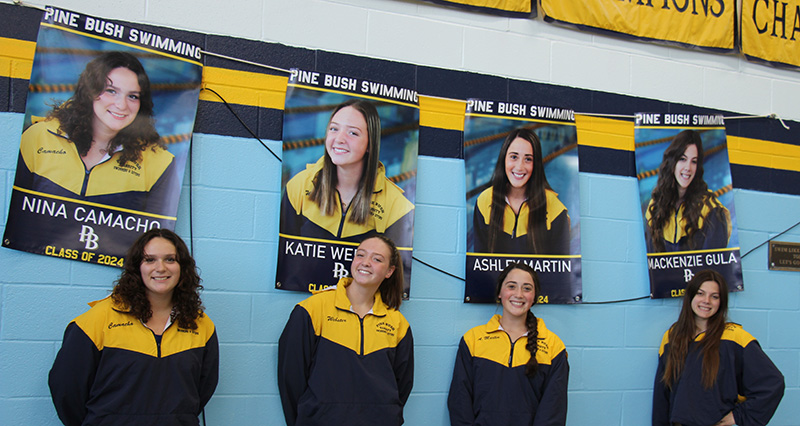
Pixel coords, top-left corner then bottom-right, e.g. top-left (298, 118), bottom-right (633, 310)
top-left (488, 127), bottom-right (552, 254)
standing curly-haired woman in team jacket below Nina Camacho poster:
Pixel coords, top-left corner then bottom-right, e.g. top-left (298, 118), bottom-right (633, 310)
top-left (49, 229), bottom-right (219, 426)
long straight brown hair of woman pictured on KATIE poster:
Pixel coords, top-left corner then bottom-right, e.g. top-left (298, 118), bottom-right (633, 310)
top-left (309, 99), bottom-right (381, 225)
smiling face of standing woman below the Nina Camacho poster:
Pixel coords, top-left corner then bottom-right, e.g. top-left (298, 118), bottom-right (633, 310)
top-left (139, 237), bottom-right (181, 300)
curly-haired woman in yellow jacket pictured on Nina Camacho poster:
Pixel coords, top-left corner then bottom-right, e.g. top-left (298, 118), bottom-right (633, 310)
top-left (15, 52), bottom-right (179, 216)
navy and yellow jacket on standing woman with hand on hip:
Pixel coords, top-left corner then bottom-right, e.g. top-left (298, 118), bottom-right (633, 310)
top-left (653, 323), bottom-right (784, 426)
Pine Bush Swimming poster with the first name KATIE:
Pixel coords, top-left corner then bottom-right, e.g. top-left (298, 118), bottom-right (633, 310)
top-left (275, 69), bottom-right (419, 298)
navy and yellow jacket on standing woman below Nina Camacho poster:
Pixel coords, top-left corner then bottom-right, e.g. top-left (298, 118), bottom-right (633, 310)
top-left (49, 297), bottom-right (219, 426)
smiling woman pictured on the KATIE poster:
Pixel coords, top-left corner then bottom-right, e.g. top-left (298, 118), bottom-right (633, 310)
top-left (281, 99), bottom-right (414, 247)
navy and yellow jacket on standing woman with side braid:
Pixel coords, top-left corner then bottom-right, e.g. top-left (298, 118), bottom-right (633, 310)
top-left (447, 315), bottom-right (569, 426)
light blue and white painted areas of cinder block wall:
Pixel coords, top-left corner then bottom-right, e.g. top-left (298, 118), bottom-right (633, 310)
top-left (0, 0), bottom-right (800, 426)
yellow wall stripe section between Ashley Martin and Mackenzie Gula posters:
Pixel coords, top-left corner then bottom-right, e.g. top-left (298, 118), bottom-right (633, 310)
top-left (575, 114), bottom-right (634, 151)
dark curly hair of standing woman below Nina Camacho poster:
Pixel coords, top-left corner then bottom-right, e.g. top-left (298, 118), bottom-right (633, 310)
top-left (111, 228), bottom-right (203, 330)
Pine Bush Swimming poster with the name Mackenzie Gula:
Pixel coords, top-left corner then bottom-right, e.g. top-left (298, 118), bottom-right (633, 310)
top-left (634, 113), bottom-right (744, 298)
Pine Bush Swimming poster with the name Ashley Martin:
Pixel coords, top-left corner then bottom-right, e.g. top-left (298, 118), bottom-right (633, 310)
top-left (464, 99), bottom-right (583, 303)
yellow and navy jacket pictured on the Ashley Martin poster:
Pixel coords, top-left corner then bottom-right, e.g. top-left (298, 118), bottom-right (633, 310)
top-left (472, 188), bottom-right (570, 254)
